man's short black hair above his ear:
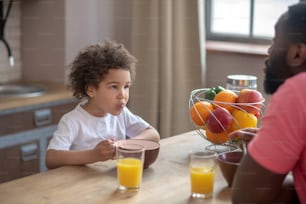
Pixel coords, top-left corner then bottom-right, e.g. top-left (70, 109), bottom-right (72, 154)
top-left (287, 2), bottom-right (306, 43)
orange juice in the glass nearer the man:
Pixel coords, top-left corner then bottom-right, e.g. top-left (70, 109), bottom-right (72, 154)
top-left (190, 167), bottom-right (215, 195)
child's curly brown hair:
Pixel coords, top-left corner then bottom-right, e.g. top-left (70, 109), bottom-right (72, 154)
top-left (68, 40), bottom-right (137, 99)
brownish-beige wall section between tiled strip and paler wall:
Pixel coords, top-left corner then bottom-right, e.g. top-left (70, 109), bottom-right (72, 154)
top-left (21, 0), bottom-right (65, 83)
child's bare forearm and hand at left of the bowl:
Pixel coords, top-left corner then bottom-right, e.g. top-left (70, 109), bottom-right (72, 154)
top-left (46, 140), bottom-right (115, 169)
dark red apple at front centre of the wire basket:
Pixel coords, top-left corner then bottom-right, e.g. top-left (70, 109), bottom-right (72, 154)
top-left (206, 107), bottom-right (233, 133)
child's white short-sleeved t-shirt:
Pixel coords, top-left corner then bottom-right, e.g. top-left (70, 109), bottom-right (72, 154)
top-left (48, 103), bottom-right (149, 150)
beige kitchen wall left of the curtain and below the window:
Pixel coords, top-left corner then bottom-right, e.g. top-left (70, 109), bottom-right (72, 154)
top-left (0, 0), bottom-right (265, 102)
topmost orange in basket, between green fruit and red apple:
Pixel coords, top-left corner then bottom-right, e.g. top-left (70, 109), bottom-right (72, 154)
top-left (214, 90), bottom-right (238, 112)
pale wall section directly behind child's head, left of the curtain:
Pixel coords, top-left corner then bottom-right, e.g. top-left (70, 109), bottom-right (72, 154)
top-left (65, 0), bottom-right (132, 83)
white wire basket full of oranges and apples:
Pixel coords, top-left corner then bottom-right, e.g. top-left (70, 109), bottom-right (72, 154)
top-left (189, 86), bottom-right (265, 152)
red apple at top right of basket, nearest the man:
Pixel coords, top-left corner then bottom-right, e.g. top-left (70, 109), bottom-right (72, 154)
top-left (237, 89), bottom-right (263, 115)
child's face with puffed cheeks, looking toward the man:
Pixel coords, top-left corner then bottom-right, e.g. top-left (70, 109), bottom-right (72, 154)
top-left (87, 69), bottom-right (131, 116)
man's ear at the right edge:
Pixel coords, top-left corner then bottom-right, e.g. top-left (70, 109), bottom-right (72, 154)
top-left (287, 43), bottom-right (306, 67)
